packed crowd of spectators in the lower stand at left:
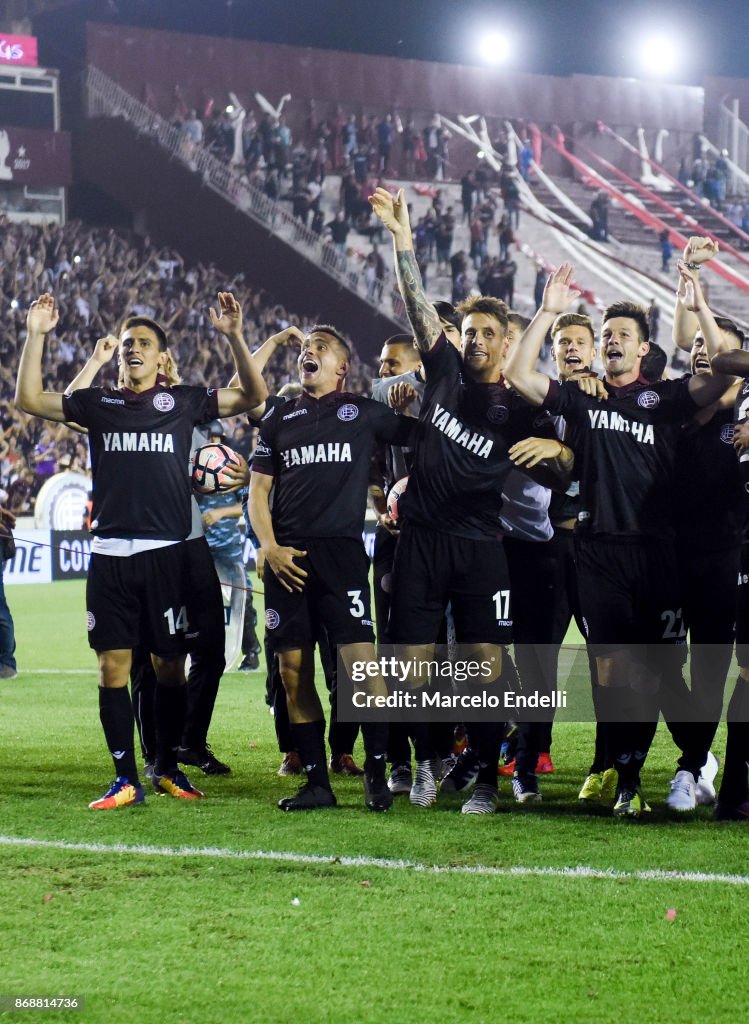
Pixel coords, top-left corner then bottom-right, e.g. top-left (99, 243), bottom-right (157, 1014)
top-left (0, 217), bottom-right (373, 515)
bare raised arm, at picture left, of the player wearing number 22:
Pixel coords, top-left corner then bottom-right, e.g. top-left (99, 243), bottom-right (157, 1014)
top-left (504, 263), bottom-right (580, 406)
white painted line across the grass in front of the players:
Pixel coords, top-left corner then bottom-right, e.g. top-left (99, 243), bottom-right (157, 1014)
top-left (0, 836), bottom-right (749, 886)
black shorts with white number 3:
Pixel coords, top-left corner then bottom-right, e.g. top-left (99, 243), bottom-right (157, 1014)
top-left (263, 538), bottom-right (374, 652)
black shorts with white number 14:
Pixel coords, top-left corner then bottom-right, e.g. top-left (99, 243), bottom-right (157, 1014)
top-left (86, 543), bottom-right (190, 658)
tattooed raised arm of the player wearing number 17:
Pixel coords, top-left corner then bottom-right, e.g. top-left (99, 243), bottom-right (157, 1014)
top-left (369, 188), bottom-right (442, 352)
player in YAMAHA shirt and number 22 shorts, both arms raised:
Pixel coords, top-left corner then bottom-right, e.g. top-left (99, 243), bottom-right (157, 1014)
top-left (506, 264), bottom-right (733, 817)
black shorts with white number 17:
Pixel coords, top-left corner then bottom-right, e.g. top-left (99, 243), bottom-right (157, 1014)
top-left (388, 523), bottom-right (512, 644)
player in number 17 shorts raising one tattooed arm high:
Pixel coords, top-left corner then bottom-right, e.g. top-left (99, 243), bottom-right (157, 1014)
top-left (370, 188), bottom-right (564, 814)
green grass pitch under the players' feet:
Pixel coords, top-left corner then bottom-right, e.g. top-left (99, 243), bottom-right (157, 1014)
top-left (0, 583), bottom-right (749, 1024)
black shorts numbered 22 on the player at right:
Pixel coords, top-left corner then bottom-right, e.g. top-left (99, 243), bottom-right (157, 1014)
top-left (576, 538), bottom-right (685, 654)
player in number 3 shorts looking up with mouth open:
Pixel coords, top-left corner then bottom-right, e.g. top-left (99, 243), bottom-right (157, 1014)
top-left (249, 325), bottom-right (413, 811)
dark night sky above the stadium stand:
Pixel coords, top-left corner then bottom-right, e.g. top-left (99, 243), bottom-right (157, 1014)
top-left (27, 0), bottom-right (749, 84)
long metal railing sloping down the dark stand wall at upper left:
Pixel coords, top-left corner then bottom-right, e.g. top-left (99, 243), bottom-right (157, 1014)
top-left (84, 66), bottom-right (410, 331)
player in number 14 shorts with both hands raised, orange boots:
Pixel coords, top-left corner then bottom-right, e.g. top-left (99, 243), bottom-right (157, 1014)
top-left (16, 292), bottom-right (267, 810)
